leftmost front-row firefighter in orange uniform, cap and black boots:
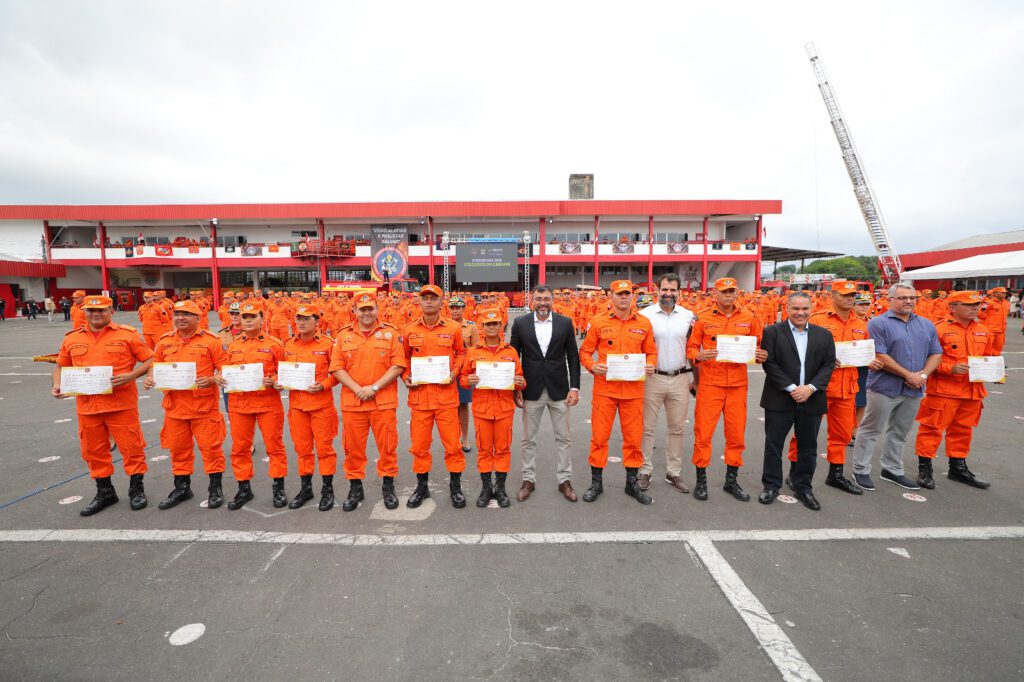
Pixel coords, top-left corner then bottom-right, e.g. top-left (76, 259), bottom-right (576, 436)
top-left (51, 292), bottom-right (153, 516)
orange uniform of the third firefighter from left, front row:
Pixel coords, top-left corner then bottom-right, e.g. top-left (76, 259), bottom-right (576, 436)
top-left (227, 334), bottom-right (288, 481)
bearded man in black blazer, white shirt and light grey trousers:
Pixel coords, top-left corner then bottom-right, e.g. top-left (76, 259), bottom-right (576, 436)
top-left (509, 287), bottom-right (580, 502)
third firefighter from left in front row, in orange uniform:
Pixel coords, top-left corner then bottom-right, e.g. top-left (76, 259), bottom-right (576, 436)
top-left (225, 302), bottom-right (288, 503)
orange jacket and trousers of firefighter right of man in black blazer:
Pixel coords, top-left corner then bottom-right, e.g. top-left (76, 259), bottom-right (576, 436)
top-left (580, 311), bottom-right (657, 469)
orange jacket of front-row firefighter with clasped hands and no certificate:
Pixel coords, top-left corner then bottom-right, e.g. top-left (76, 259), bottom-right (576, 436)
top-left (330, 323), bottom-right (405, 412)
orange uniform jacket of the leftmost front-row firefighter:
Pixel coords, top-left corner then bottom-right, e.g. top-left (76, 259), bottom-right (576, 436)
top-left (57, 323), bottom-right (153, 415)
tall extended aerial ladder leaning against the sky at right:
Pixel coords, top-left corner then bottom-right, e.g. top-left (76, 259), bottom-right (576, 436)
top-left (804, 43), bottom-right (903, 285)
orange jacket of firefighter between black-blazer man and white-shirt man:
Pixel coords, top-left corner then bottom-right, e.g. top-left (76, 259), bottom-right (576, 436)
top-left (580, 311), bottom-right (657, 399)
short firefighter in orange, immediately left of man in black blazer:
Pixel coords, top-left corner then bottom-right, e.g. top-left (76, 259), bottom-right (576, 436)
top-left (460, 308), bottom-right (526, 507)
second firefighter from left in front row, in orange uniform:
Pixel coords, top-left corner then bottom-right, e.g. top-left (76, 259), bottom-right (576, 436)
top-left (142, 300), bottom-right (227, 509)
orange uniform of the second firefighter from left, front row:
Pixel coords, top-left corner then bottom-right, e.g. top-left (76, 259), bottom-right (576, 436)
top-left (154, 330), bottom-right (227, 476)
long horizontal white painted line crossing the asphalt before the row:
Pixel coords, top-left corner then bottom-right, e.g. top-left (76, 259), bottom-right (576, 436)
top-left (0, 522), bottom-right (1024, 547)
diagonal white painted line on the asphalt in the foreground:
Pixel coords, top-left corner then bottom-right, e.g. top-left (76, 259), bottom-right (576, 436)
top-left (688, 538), bottom-right (821, 682)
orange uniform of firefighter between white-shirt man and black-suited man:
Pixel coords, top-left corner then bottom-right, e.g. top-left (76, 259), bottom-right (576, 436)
top-left (686, 304), bottom-right (763, 469)
